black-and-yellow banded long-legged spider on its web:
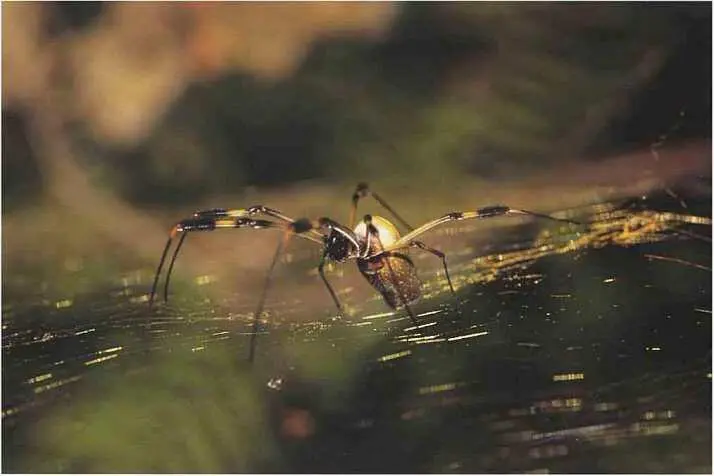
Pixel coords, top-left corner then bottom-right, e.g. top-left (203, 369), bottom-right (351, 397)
top-left (149, 183), bottom-right (578, 362)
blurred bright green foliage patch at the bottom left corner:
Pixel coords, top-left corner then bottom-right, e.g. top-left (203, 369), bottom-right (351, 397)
top-left (11, 344), bottom-right (280, 473)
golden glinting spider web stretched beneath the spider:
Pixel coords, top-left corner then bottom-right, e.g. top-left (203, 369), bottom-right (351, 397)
top-left (3, 183), bottom-right (711, 472)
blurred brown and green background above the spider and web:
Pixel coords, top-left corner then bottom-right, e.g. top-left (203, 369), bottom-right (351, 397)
top-left (2, 2), bottom-right (711, 302)
